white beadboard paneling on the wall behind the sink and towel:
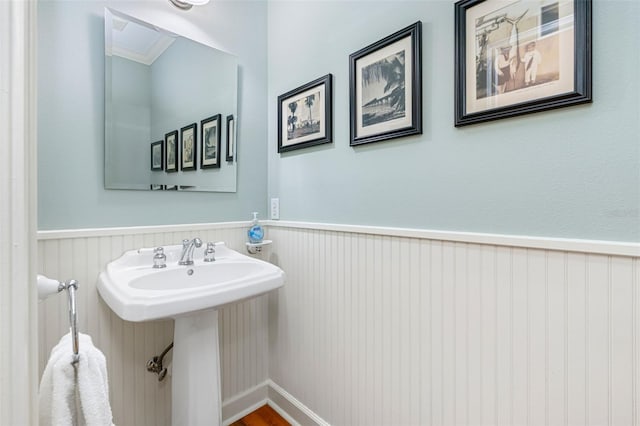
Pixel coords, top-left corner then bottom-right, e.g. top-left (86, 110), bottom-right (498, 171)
top-left (38, 224), bottom-right (268, 426)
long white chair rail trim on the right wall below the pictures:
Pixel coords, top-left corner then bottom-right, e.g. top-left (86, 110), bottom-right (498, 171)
top-left (263, 220), bottom-right (640, 257)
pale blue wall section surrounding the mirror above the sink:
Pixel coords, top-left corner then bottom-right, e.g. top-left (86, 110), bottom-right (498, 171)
top-left (38, 0), bottom-right (267, 230)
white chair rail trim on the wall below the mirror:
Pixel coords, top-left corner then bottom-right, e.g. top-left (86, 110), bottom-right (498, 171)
top-left (38, 221), bottom-right (251, 240)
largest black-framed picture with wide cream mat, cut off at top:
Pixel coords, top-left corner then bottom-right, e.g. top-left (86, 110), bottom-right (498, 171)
top-left (454, 0), bottom-right (591, 126)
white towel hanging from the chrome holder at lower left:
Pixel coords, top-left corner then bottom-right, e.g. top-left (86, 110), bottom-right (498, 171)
top-left (39, 333), bottom-right (112, 426)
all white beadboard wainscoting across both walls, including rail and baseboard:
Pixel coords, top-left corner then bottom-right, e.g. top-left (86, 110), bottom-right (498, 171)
top-left (38, 222), bottom-right (640, 426)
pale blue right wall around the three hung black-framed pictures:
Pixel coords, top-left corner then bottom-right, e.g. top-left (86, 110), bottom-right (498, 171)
top-left (268, 0), bottom-right (640, 241)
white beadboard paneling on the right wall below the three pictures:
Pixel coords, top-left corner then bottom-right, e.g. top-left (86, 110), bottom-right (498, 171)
top-left (269, 224), bottom-right (640, 426)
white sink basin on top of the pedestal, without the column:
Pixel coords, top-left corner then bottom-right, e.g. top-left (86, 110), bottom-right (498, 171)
top-left (98, 243), bottom-right (284, 321)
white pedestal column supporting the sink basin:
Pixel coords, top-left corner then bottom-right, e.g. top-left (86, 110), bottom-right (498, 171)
top-left (171, 309), bottom-right (222, 426)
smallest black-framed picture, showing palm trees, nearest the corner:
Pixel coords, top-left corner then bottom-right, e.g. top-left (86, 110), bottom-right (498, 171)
top-left (278, 74), bottom-right (333, 152)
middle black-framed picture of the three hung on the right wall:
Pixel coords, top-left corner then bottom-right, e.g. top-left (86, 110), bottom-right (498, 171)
top-left (349, 21), bottom-right (422, 146)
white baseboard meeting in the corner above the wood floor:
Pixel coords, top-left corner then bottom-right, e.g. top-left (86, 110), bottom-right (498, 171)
top-left (222, 380), bottom-right (329, 426)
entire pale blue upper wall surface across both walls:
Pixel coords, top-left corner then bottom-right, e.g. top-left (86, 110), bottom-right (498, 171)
top-left (38, 0), bottom-right (640, 241)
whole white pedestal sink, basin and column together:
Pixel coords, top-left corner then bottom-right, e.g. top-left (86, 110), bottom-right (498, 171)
top-left (98, 243), bottom-right (284, 426)
